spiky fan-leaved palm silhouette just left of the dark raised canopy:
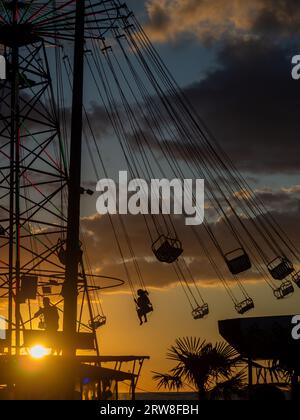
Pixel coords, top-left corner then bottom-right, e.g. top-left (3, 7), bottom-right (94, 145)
top-left (153, 337), bottom-right (245, 400)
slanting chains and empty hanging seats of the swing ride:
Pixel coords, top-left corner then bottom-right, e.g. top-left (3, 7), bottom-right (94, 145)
top-left (51, 0), bottom-right (300, 327)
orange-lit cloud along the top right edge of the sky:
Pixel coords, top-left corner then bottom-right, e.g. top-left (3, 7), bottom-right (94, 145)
top-left (146, 0), bottom-right (300, 42)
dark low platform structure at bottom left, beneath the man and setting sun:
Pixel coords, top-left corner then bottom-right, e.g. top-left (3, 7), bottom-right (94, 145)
top-left (0, 355), bottom-right (149, 400)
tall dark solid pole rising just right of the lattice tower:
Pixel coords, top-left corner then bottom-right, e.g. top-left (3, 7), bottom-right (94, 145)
top-left (63, 0), bottom-right (85, 358)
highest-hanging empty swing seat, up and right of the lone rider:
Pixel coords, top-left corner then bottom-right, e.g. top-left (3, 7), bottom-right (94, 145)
top-left (152, 235), bottom-right (183, 264)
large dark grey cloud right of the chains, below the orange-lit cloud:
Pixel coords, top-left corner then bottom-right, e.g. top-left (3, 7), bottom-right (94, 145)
top-left (169, 41), bottom-right (300, 174)
